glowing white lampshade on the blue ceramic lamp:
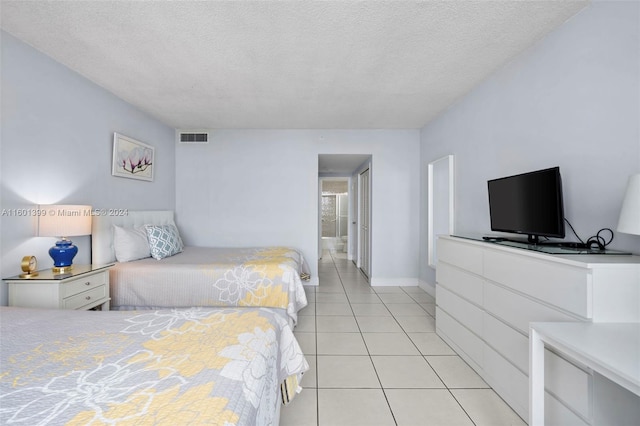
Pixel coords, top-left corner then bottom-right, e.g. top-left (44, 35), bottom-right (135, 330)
top-left (38, 204), bottom-right (91, 237)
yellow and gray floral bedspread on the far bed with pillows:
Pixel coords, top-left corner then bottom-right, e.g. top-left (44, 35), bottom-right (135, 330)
top-left (110, 247), bottom-right (308, 324)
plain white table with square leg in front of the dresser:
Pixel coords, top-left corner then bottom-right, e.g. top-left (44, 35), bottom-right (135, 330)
top-left (529, 322), bottom-right (640, 426)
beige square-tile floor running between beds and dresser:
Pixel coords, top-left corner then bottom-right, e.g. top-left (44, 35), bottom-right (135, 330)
top-left (280, 252), bottom-right (525, 426)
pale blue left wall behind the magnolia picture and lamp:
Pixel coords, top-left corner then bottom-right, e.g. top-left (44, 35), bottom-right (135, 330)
top-left (0, 32), bottom-right (175, 305)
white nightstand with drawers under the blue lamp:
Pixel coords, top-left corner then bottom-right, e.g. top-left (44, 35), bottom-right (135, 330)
top-left (4, 265), bottom-right (111, 311)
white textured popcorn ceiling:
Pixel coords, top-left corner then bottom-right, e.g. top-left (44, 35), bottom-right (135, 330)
top-left (0, 0), bottom-right (588, 129)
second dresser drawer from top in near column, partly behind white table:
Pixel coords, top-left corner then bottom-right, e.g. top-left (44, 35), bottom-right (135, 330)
top-left (484, 282), bottom-right (576, 336)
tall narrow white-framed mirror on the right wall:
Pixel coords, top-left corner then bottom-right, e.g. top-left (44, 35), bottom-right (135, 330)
top-left (427, 154), bottom-right (455, 269)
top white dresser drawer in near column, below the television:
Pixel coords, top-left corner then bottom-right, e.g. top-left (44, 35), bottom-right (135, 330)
top-left (484, 250), bottom-right (592, 318)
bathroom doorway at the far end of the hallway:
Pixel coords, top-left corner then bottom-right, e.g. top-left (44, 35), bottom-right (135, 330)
top-left (320, 178), bottom-right (349, 254)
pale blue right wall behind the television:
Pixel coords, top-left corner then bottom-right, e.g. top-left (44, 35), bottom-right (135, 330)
top-left (420, 1), bottom-right (640, 290)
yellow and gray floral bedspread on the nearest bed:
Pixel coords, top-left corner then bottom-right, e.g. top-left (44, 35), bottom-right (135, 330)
top-left (0, 307), bottom-right (308, 426)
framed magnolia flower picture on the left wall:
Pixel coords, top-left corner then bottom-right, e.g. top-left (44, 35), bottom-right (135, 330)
top-left (111, 133), bottom-right (155, 182)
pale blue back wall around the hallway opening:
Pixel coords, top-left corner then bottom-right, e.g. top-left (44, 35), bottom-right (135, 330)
top-left (176, 130), bottom-right (420, 285)
